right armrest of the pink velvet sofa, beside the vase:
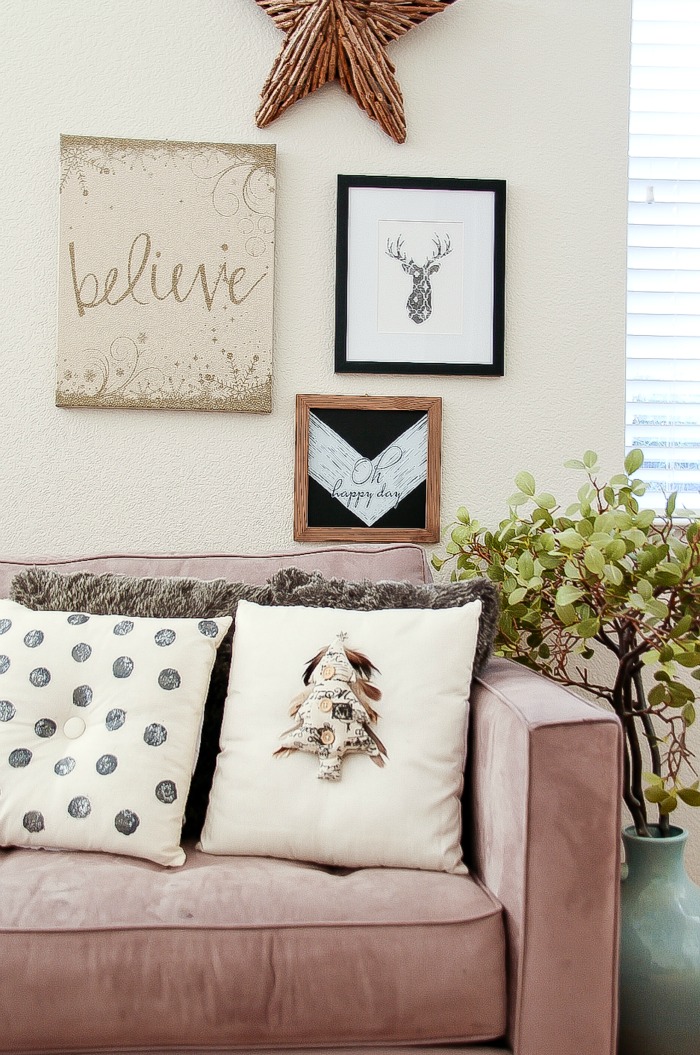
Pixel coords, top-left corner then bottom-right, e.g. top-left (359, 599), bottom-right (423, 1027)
top-left (466, 659), bottom-right (622, 1055)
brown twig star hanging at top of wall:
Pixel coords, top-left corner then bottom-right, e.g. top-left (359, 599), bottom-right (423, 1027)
top-left (255, 0), bottom-right (454, 142)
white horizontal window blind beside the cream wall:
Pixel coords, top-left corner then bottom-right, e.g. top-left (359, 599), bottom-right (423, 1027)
top-left (625, 0), bottom-right (700, 511)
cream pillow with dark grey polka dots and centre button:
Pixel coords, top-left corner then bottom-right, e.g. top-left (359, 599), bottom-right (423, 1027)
top-left (0, 600), bottom-right (232, 865)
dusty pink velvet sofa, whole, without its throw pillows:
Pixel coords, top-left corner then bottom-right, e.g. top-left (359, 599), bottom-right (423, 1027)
top-left (0, 545), bottom-right (621, 1055)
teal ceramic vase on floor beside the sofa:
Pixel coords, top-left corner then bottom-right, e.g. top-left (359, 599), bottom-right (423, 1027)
top-left (619, 827), bottom-right (700, 1055)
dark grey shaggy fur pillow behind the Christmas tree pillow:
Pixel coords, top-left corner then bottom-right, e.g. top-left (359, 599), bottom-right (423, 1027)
top-left (265, 568), bottom-right (500, 674)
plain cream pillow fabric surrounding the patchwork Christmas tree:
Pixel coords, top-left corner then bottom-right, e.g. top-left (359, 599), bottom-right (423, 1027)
top-left (200, 600), bottom-right (481, 871)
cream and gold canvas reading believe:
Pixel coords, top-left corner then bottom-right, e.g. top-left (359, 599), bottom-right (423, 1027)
top-left (56, 136), bottom-right (275, 414)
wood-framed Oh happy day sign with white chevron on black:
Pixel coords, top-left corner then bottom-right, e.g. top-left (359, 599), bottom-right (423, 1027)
top-left (294, 395), bottom-right (442, 542)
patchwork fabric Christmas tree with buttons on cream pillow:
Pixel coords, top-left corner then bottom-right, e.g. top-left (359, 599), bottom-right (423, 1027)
top-left (274, 633), bottom-right (388, 781)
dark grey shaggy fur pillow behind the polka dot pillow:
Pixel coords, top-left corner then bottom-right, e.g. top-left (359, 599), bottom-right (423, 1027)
top-left (9, 568), bottom-right (270, 839)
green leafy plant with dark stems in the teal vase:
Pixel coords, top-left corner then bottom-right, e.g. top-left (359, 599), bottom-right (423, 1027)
top-left (432, 449), bottom-right (700, 836)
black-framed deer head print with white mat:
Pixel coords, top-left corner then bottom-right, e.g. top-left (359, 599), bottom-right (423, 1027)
top-left (335, 175), bottom-right (506, 377)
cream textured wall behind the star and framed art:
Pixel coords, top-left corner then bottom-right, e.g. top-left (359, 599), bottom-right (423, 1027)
top-left (9, 0), bottom-right (700, 877)
